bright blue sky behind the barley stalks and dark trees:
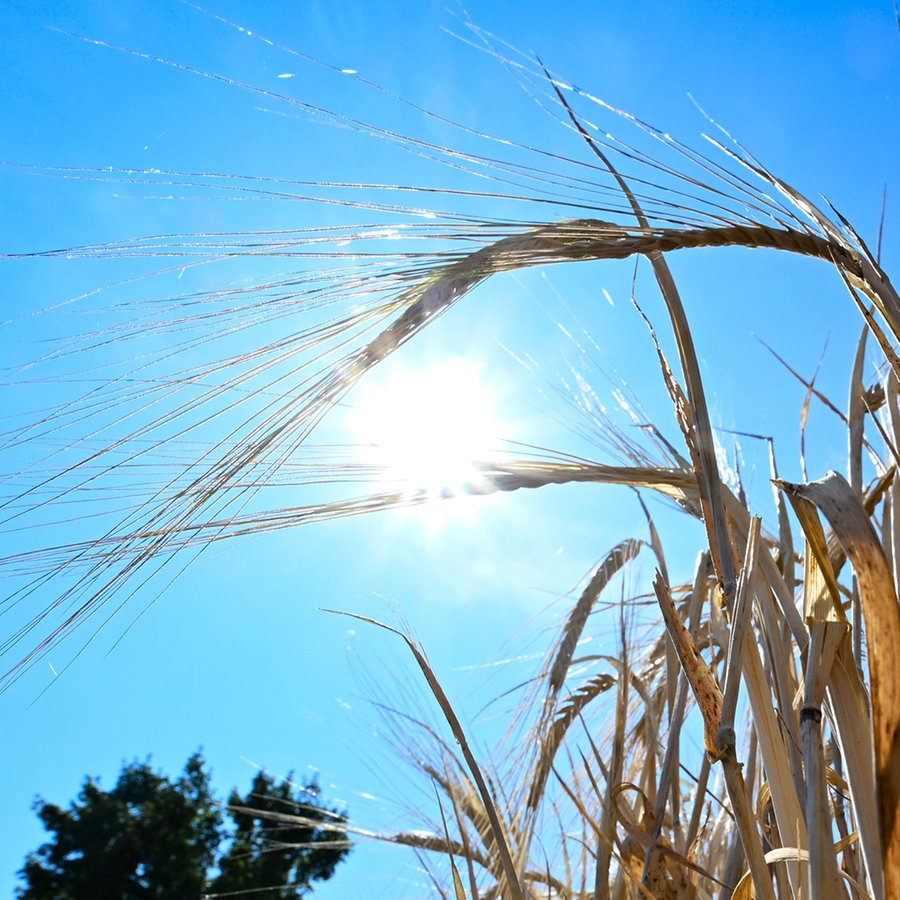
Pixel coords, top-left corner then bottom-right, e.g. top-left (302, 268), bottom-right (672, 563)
top-left (0, 0), bottom-right (900, 898)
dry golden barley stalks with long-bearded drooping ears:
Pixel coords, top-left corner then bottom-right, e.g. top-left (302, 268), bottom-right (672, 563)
top-left (0, 21), bottom-right (900, 900)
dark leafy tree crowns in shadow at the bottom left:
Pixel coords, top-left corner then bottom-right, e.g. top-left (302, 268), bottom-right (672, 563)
top-left (17, 753), bottom-right (350, 900)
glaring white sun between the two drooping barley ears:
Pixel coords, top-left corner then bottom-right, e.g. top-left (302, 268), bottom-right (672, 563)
top-left (347, 357), bottom-right (510, 498)
